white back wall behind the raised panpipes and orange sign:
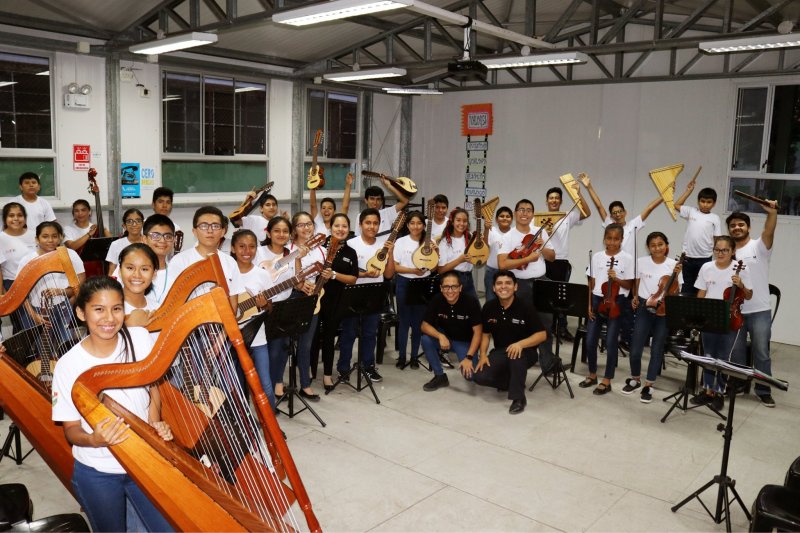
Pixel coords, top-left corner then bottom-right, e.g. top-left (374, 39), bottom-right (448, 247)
top-left (412, 80), bottom-right (800, 344)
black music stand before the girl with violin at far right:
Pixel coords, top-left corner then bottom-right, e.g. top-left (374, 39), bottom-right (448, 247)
top-left (661, 296), bottom-right (730, 423)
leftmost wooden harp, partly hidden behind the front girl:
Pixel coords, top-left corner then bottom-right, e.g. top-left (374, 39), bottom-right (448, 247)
top-left (0, 247), bottom-right (83, 491)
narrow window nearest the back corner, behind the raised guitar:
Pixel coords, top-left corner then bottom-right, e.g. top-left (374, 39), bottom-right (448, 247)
top-left (305, 89), bottom-right (358, 190)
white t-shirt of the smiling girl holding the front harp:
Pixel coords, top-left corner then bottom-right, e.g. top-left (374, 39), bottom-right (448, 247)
top-left (52, 328), bottom-right (153, 474)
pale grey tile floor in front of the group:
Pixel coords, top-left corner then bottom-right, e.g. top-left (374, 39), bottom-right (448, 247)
top-left (0, 332), bottom-right (800, 531)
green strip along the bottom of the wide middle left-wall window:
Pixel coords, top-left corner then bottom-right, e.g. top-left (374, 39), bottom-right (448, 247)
top-left (161, 161), bottom-right (268, 193)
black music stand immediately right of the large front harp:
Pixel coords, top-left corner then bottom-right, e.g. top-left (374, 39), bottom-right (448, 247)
top-left (264, 296), bottom-right (325, 427)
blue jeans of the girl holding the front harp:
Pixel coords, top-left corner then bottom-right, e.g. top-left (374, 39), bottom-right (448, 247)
top-left (72, 461), bottom-right (174, 531)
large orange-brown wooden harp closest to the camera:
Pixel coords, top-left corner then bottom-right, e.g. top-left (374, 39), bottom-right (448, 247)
top-left (72, 288), bottom-right (320, 531)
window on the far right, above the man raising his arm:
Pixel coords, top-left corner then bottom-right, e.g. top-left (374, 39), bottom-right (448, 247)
top-left (727, 84), bottom-right (800, 216)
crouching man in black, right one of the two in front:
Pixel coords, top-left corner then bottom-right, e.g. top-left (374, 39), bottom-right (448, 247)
top-left (465, 270), bottom-right (552, 415)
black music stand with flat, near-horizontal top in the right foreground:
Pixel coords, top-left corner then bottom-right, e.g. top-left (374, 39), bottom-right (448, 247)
top-left (668, 354), bottom-right (789, 532)
